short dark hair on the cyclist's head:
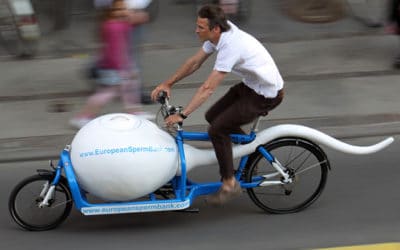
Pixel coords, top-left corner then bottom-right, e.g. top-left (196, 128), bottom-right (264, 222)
top-left (197, 4), bottom-right (231, 32)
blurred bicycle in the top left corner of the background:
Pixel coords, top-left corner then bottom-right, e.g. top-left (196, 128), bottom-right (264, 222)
top-left (0, 0), bottom-right (40, 57)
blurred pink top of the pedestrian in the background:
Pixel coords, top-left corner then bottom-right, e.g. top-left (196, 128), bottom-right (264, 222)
top-left (100, 20), bottom-right (133, 70)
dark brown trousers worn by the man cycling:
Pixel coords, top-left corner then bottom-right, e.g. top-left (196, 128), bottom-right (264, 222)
top-left (206, 83), bottom-right (283, 179)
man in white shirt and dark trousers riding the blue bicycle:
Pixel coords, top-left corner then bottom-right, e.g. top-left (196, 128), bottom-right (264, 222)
top-left (151, 5), bottom-right (284, 204)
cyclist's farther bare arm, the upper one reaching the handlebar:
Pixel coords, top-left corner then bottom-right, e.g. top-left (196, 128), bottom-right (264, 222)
top-left (151, 48), bottom-right (210, 100)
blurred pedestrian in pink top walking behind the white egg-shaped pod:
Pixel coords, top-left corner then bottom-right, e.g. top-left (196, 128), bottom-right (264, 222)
top-left (70, 0), bottom-right (153, 128)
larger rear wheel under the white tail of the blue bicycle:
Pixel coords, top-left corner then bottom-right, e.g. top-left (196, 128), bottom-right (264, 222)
top-left (245, 138), bottom-right (330, 214)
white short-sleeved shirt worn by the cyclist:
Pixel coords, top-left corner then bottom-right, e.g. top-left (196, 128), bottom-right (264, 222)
top-left (203, 21), bottom-right (283, 98)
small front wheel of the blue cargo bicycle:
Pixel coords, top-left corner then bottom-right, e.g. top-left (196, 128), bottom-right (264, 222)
top-left (8, 175), bottom-right (73, 231)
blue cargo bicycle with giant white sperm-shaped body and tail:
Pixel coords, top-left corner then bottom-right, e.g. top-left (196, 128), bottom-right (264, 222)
top-left (9, 93), bottom-right (394, 231)
